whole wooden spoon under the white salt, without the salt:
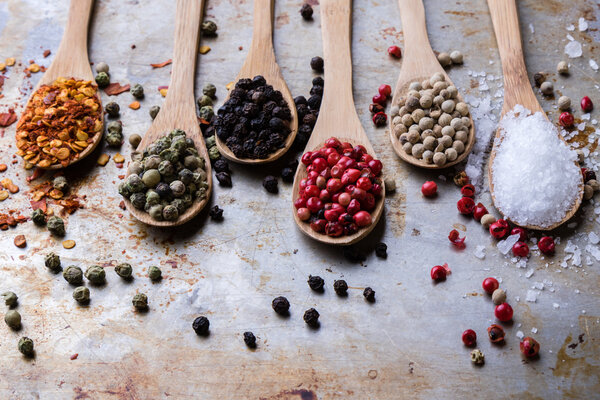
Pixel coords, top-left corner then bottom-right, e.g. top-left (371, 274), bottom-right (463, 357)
top-left (488, 0), bottom-right (583, 231)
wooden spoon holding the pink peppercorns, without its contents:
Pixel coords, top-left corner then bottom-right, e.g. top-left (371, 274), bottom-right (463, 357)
top-left (292, 0), bottom-right (385, 245)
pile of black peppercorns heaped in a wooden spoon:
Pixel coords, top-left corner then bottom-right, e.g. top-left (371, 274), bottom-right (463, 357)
top-left (213, 75), bottom-right (292, 159)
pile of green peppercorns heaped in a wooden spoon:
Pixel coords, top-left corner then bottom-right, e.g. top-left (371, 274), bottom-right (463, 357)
top-left (119, 129), bottom-right (208, 221)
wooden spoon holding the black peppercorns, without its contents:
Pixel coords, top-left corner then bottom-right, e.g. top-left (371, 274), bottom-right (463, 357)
top-left (215, 0), bottom-right (298, 165)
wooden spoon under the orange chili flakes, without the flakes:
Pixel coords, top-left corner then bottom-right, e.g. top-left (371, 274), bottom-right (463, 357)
top-left (20, 0), bottom-right (104, 169)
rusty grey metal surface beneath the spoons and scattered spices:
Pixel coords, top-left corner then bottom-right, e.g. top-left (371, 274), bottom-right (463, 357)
top-left (0, 0), bottom-right (600, 399)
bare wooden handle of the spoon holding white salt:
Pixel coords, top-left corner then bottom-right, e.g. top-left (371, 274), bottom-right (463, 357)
top-left (488, 0), bottom-right (541, 114)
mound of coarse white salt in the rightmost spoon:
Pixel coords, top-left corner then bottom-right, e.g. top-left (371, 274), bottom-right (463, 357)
top-left (492, 105), bottom-right (581, 228)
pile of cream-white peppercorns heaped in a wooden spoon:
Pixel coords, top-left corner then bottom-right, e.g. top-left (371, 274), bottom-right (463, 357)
top-left (391, 72), bottom-right (471, 167)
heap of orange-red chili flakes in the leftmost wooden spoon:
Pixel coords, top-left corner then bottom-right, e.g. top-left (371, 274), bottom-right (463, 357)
top-left (16, 78), bottom-right (102, 168)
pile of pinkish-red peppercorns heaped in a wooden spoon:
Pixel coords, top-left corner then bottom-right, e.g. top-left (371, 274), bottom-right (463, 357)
top-left (294, 137), bottom-right (383, 237)
